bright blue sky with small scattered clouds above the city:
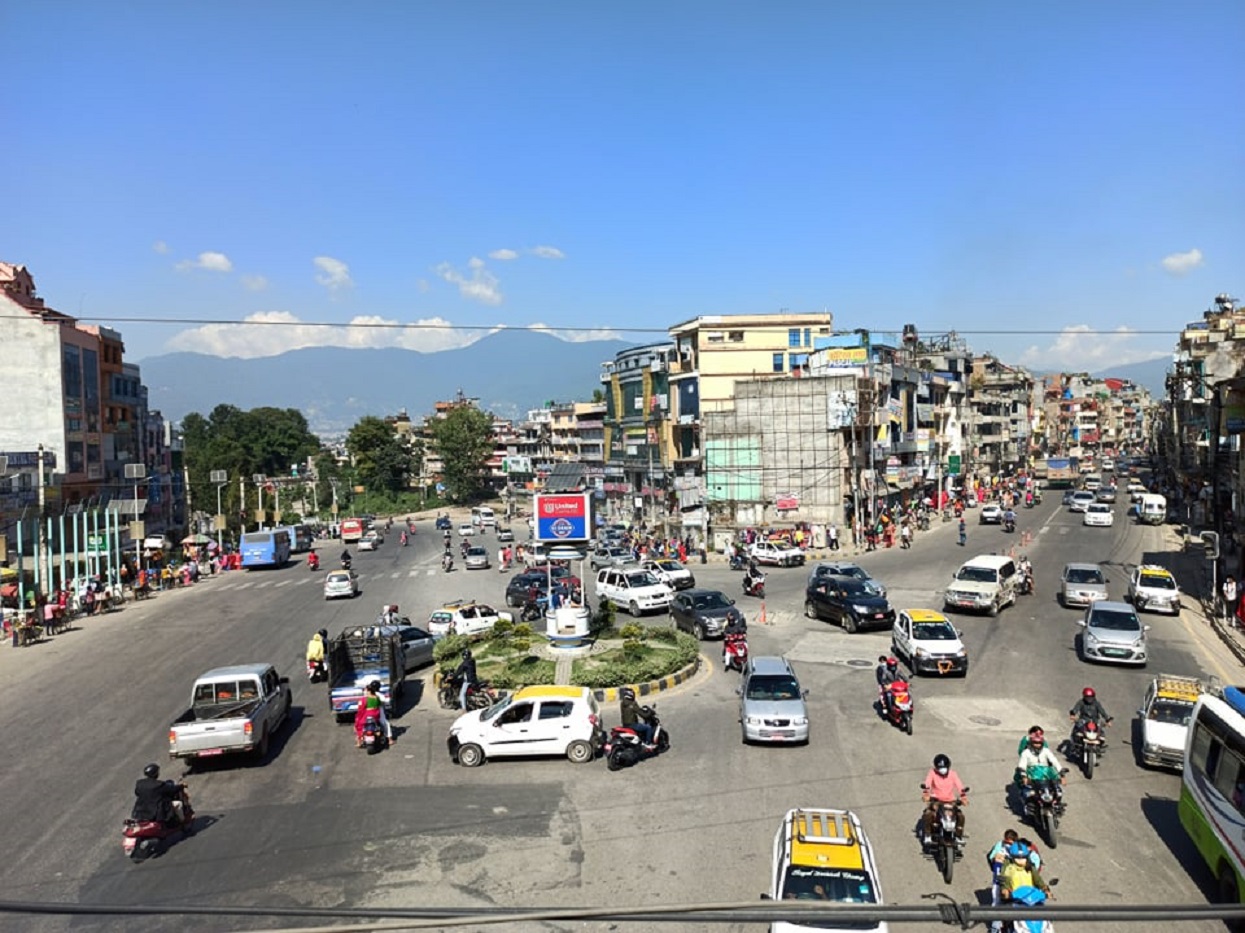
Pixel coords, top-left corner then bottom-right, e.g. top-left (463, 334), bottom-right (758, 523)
top-left (0, 0), bottom-right (1245, 370)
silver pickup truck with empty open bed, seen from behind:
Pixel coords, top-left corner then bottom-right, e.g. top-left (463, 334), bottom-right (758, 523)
top-left (168, 664), bottom-right (290, 760)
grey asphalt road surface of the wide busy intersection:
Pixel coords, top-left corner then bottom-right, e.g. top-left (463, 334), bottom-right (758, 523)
top-left (0, 497), bottom-right (1239, 931)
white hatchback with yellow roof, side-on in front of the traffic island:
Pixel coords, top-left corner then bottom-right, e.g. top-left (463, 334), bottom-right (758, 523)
top-left (446, 685), bottom-right (604, 767)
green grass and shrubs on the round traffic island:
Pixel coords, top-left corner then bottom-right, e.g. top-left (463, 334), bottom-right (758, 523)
top-left (433, 604), bottom-right (700, 690)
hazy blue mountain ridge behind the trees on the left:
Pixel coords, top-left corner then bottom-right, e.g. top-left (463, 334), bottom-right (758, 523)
top-left (139, 330), bottom-right (630, 433)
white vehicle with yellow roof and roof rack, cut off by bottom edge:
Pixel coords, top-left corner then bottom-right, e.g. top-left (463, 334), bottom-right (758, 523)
top-left (763, 807), bottom-right (888, 933)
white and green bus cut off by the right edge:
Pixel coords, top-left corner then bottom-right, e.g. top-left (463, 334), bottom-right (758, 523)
top-left (1178, 686), bottom-right (1245, 904)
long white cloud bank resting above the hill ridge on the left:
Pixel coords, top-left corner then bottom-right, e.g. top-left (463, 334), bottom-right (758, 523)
top-left (164, 311), bottom-right (484, 359)
